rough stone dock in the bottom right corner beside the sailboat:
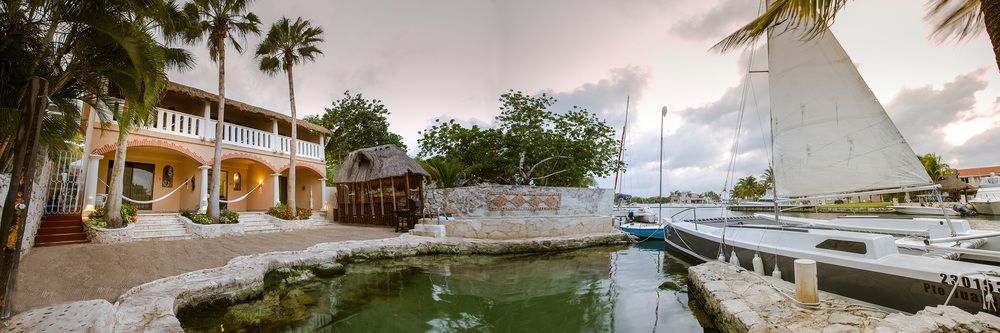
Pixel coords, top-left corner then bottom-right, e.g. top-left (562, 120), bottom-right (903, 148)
top-left (688, 261), bottom-right (1000, 333)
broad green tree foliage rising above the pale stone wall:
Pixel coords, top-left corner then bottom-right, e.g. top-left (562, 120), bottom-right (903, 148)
top-left (418, 90), bottom-right (618, 187)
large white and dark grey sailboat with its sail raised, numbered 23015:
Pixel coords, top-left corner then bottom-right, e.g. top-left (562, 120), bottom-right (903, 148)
top-left (665, 19), bottom-right (1000, 314)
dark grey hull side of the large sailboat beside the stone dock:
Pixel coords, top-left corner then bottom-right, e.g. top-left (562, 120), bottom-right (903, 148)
top-left (665, 225), bottom-right (997, 315)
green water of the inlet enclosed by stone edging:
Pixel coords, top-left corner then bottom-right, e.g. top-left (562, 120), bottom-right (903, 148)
top-left (181, 242), bottom-right (704, 332)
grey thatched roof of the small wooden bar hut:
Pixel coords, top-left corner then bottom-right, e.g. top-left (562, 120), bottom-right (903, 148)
top-left (333, 145), bottom-right (430, 183)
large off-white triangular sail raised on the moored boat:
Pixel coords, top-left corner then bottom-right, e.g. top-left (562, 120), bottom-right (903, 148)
top-left (768, 27), bottom-right (931, 197)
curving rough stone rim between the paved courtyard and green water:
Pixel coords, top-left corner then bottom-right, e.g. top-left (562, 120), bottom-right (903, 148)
top-left (109, 233), bottom-right (629, 332)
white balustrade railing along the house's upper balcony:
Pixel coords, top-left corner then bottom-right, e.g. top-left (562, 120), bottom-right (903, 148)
top-left (105, 100), bottom-right (323, 160)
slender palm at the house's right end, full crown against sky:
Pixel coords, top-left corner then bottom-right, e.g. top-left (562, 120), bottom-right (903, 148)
top-left (257, 17), bottom-right (323, 213)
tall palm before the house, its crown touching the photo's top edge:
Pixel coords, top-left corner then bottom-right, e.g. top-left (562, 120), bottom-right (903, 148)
top-left (184, 0), bottom-right (262, 222)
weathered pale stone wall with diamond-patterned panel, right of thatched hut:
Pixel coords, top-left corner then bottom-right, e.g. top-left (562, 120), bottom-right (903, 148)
top-left (421, 185), bottom-right (614, 239)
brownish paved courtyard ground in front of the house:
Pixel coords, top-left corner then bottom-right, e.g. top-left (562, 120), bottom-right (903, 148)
top-left (14, 224), bottom-right (399, 313)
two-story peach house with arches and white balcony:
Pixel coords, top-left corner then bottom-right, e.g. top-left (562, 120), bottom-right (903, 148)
top-left (82, 83), bottom-right (329, 215)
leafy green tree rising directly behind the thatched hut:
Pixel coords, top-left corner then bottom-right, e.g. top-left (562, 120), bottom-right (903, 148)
top-left (305, 91), bottom-right (406, 185)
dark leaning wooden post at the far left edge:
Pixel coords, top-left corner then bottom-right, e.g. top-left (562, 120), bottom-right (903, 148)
top-left (0, 77), bottom-right (49, 318)
